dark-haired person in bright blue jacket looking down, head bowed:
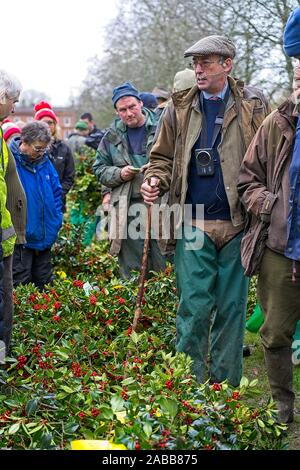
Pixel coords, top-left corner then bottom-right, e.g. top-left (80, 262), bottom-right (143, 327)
top-left (10, 121), bottom-right (62, 289)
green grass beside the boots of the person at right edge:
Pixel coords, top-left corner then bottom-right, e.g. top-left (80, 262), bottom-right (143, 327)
top-left (244, 332), bottom-right (300, 450)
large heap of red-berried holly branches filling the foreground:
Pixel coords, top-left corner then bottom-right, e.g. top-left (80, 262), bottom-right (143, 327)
top-left (0, 268), bottom-right (284, 450)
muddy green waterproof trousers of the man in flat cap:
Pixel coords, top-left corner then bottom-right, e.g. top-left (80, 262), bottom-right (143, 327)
top-left (175, 229), bottom-right (249, 386)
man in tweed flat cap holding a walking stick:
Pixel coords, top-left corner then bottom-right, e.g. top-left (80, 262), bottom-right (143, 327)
top-left (141, 35), bottom-right (269, 386)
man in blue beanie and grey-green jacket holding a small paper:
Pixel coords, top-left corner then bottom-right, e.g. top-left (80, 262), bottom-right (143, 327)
top-left (93, 82), bottom-right (165, 278)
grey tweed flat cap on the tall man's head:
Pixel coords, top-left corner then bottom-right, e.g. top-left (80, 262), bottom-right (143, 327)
top-left (184, 35), bottom-right (236, 59)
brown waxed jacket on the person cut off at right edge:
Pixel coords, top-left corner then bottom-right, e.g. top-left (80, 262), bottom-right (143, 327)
top-left (237, 97), bottom-right (300, 276)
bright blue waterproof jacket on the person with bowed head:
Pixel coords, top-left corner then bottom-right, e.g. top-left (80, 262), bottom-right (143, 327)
top-left (10, 139), bottom-right (62, 251)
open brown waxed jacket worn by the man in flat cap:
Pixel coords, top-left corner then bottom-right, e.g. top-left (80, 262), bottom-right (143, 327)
top-left (145, 77), bottom-right (270, 253)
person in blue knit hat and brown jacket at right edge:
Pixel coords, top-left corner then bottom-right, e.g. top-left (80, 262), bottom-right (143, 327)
top-left (238, 11), bottom-right (300, 423)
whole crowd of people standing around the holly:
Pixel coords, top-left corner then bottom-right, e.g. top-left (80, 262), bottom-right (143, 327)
top-left (0, 7), bottom-right (300, 423)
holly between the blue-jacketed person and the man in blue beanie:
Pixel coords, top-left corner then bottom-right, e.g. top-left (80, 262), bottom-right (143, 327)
top-left (52, 145), bottom-right (117, 284)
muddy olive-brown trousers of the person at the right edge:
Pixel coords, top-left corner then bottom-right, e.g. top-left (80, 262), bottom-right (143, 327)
top-left (258, 248), bottom-right (300, 422)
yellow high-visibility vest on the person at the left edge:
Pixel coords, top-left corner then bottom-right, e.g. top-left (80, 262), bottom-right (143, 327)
top-left (0, 128), bottom-right (16, 257)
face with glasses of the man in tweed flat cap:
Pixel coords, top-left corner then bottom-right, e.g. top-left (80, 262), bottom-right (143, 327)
top-left (193, 54), bottom-right (232, 93)
